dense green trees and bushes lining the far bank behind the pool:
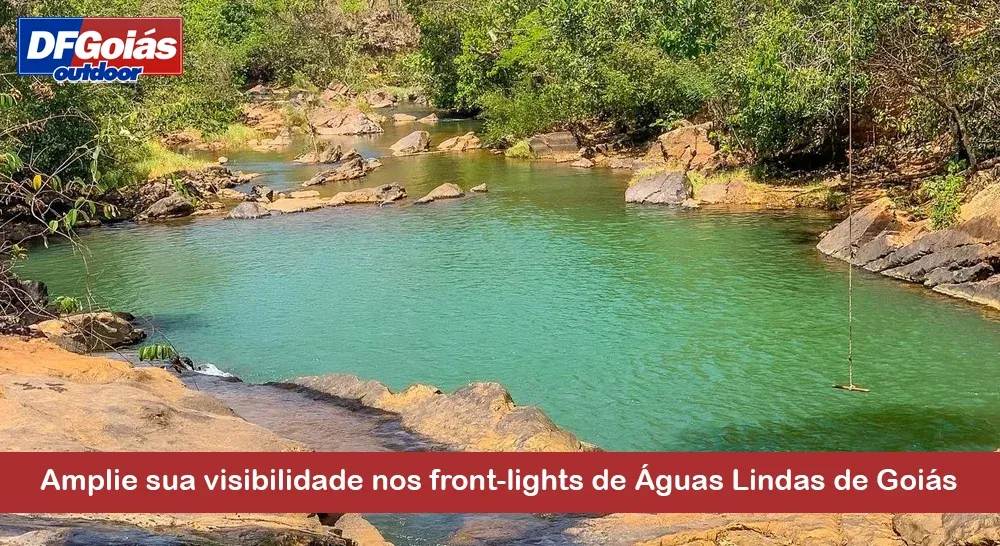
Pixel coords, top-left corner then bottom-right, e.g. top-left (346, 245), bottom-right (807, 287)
top-left (0, 0), bottom-right (1000, 240)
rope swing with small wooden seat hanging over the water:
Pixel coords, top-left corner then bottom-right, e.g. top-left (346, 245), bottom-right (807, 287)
top-left (833, 0), bottom-right (868, 392)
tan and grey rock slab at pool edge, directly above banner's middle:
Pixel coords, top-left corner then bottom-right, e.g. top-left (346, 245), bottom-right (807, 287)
top-left (289, 374), bottom-right (593, 451)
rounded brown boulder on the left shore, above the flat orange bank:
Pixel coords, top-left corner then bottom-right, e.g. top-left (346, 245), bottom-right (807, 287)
top-left (32, 311), bottom-right (146, 353)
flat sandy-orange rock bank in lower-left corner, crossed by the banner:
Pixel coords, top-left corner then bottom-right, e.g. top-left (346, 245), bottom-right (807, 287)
top-left (0, 336), bottom-right (384, 546)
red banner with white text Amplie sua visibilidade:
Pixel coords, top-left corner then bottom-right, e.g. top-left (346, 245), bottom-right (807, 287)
top-left (0, 452), bottom-right (1000, 513)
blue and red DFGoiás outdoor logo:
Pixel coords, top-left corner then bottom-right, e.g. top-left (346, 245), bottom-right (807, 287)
top-left (17, 17), bottom-right (184, 82)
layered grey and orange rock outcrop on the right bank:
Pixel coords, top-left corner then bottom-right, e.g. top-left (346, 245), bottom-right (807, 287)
top-left (816, 185), bottom-right (1000, 309)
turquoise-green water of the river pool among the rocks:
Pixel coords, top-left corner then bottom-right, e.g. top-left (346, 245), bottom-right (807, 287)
top-left (23, 119), bottom-right (1000, 450)
